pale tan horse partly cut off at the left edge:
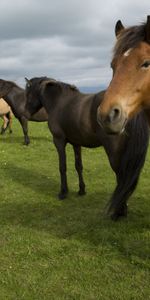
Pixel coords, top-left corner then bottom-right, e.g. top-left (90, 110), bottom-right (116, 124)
top-left (0, 98), bottom-right (13, 134)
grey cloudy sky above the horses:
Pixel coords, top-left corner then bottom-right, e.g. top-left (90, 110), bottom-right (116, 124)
top-left (0, 0), bottom-right (150, 92)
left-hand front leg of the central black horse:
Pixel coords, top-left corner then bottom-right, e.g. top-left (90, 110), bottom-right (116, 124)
top-left (53, 137), bottom-right (68, 200)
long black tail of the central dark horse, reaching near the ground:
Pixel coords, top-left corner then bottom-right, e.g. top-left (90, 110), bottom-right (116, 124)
top-left (108, 112), bottom-right (149, 220)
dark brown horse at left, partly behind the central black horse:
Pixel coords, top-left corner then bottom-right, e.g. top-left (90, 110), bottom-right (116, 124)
top-left (0, 79), bottom-right (48, 145)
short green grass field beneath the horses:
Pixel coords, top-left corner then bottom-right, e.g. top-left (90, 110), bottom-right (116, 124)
top-left (0, 120), bottom-right (150, 300)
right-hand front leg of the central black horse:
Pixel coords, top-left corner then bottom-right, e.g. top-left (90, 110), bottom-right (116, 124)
top-left (73, 146), bottom-right (85, 196)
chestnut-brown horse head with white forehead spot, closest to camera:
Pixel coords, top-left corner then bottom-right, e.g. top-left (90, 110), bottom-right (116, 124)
top-left (97, 16), bottom-right (150, 133)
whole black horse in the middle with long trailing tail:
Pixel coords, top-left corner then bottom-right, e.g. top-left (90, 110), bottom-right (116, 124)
top-left (25, 77), bottom-right (149, 220)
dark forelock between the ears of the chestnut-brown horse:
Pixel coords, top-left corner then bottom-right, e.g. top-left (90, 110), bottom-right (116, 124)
top-left (113, 23), bottom-right (146, 58)
